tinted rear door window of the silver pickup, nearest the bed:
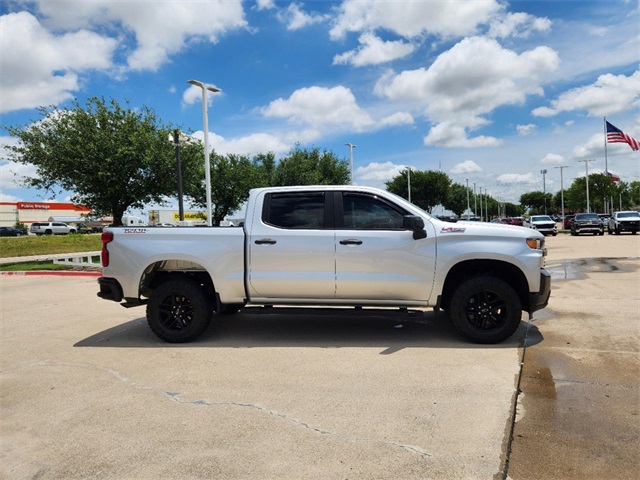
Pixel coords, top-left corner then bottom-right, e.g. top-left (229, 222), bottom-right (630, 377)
top-left (262, 192), bottom-right (324, 230)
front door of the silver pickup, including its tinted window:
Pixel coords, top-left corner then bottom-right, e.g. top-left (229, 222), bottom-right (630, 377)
top-left (334, 191), bottom-right (436, 303)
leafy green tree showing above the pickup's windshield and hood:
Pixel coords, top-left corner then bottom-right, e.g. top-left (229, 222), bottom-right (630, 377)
top-left (386, 170), bottom-right (451, 212)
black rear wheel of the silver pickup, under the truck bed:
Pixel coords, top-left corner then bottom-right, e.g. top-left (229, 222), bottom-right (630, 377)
top-left (147, 278), bottom-right (213, 343)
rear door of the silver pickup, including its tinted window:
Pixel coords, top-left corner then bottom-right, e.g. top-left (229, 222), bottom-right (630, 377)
top-left (247, 191), bottom-right (335, 300)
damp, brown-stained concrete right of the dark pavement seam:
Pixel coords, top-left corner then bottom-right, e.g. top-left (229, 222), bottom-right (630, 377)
top-left (508, 258), bottom-right (640, 479)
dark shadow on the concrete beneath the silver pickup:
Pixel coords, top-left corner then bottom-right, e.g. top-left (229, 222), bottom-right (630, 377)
top-left (74, 307), bottom-right (542, 355)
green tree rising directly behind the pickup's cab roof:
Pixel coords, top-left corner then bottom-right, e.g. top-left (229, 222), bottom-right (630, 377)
top-left (272, 145), bottom-right (350, 186)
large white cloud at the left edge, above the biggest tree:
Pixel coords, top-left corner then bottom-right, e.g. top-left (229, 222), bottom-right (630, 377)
top-left (0, 12), bottom-right (116, 112)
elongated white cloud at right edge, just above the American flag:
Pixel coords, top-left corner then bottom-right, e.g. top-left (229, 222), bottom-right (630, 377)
top-left (532, 70), bottom-right (640, 117)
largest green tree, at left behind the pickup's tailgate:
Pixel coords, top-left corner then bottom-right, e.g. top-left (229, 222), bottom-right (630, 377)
top-left (5, 97), bottom-right (200, 225)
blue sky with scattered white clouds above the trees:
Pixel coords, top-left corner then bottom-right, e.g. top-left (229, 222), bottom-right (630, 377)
top-left (0, 0), bottom-right (640, 212)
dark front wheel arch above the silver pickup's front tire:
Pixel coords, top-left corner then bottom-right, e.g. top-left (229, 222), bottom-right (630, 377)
top-left (438, 259), bottom-right (529, 311)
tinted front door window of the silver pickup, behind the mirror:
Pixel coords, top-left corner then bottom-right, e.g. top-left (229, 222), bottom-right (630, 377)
top-left (342, 192), bottom-right (406, 230)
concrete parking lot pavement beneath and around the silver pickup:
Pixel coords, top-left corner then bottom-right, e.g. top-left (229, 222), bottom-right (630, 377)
top-left (0, 236), bottom-right (640, 479)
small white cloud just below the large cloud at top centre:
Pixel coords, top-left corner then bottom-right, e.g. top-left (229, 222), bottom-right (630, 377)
top-left (333, 33), bottom-right (415, 67)
